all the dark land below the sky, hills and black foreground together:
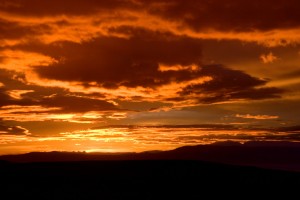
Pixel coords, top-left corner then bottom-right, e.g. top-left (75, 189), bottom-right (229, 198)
top-left (0, 142), bottom-right (300, 199)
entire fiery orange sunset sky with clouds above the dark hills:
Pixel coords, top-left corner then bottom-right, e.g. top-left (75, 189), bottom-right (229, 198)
top-left (0, 0), bottom-right (300, 154)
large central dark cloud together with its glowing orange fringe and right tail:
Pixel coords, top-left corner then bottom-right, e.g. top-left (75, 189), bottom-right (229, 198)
top-left (0, 26), bottom-right (283, 106)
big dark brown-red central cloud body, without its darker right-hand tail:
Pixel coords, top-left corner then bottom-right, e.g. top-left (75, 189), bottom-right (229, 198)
top-left (36, 30), bottom-right (201, 88)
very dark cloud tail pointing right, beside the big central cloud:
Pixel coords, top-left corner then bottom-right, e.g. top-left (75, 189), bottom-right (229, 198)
top-left (179, 65), bottom-right (283, 103)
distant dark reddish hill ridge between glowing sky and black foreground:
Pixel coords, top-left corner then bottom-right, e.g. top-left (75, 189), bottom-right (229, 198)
top-left (0, 142), bottom-right (300, 171)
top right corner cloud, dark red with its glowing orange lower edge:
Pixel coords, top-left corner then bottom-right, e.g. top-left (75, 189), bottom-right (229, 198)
top-left (139, 0), bottom-right (300, 46)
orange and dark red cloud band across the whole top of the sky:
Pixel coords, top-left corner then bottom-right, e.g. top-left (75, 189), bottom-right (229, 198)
top-left (0, 0), bottom-right (300, 46)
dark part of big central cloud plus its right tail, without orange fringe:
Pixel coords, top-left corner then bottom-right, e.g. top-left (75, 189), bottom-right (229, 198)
top-left (20, 30), bottom-right (283, 103)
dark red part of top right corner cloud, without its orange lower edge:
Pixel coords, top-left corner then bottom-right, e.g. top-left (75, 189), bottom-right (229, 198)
top-left (140, 0), bottom-right (300, 31)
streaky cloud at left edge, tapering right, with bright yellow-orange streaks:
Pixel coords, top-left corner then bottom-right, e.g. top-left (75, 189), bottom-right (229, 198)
top-left (0, 73), bottom-right (122, 123)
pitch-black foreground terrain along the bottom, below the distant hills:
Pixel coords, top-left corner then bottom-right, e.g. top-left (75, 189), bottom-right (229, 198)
top-left (0, 160), bottom-right (300, 199)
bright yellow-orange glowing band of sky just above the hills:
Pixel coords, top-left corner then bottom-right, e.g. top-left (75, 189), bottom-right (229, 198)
top-left (0, 126), bottom-right (300, 154)
